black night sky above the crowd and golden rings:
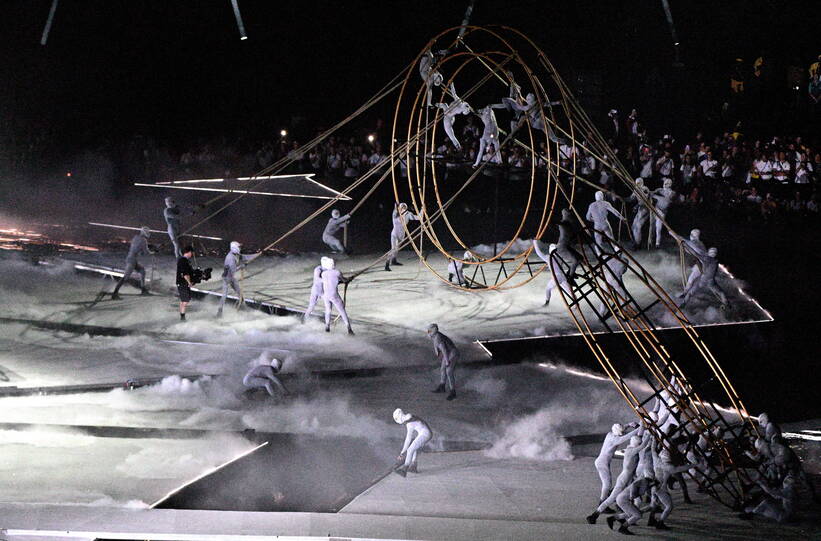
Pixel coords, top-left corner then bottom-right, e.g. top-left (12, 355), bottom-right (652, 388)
top-left (0, 0), bottom-right (821, 148)
